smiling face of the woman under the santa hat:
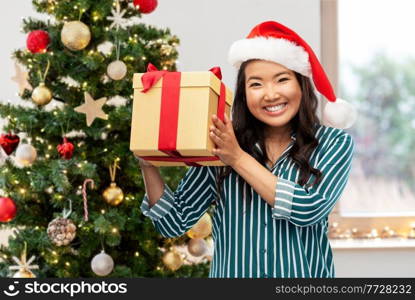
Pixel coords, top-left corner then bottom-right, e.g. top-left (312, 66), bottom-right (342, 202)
top-left (245, 60), bottom-right (302, 131)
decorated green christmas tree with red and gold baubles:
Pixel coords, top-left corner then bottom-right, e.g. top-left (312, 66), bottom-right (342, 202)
top-left (0, 0), bottom-right (213, 277)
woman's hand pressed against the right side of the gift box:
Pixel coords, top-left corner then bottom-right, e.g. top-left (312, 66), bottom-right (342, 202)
top-left (209, 114), bottom-right (243, 166)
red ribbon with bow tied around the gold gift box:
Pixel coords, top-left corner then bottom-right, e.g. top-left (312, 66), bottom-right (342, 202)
top-left (140, 63), bottom-right (226, 166)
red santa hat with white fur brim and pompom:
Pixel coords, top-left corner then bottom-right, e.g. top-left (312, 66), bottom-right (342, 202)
top-left (228, 21), bottom-right (357, 129)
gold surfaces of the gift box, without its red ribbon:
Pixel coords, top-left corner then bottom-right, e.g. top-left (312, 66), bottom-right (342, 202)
top-left (130, 71), bottom-right (233, 166)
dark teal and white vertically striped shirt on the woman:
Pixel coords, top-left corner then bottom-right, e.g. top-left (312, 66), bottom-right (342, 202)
top-left (141, 125), bottom-right (354, 278)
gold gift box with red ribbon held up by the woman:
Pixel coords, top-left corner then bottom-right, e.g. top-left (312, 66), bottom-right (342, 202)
top-left (130, 64), bottom-right (233, 166)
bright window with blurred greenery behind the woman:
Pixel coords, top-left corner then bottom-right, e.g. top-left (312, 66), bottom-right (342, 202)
top-left (321, 0), bottom-right (415, 239)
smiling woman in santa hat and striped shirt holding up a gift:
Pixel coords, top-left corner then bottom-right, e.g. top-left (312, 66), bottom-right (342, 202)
top-left (140, 22), bottom-right (355, 278)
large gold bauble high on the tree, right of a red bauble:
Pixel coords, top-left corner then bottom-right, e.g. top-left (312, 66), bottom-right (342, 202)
top-left (61, 21), bottom-right (91, 51)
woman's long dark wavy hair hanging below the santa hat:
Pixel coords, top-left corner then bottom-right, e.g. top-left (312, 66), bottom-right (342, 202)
top-left (216, 60), bottom-right (322, 203)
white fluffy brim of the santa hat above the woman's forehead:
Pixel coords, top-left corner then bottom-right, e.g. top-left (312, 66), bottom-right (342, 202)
top-left (228, 37), bottom-right (311, 78)
